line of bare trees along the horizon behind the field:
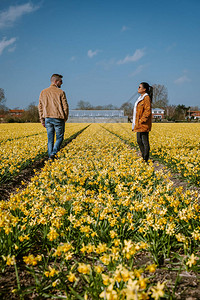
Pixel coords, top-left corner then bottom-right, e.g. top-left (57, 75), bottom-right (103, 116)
top-left (0, 84), bottom-right (199, 122)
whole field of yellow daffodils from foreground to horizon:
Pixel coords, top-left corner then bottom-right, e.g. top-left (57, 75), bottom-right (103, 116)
top-left (0, 124), bottom-right (200, 300)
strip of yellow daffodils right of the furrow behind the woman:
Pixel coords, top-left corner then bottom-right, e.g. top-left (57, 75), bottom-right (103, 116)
top-left (101, 123), bottom-right (200, 186)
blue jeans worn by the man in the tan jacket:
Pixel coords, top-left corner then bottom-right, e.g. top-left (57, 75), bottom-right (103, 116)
top-left (45, 118), bottom-right (65, 157)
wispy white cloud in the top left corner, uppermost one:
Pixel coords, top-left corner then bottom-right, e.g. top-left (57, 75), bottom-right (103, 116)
top-left (0, 3), bottom-right (39, 28)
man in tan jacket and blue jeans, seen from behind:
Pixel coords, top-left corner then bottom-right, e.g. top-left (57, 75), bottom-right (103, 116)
top-left (38, 74), bottom-right (69, 160)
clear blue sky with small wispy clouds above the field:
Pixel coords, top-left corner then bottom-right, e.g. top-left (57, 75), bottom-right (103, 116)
top-left (0, 0), bottom-right (200, 109)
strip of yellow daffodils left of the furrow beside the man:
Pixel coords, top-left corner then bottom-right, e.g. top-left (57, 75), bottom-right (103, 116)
top-left (0, 124), bottom-right (87, 183)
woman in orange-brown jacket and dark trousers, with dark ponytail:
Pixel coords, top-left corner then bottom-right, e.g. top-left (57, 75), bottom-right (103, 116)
top-left (132, 82), bottom-right (153, 162)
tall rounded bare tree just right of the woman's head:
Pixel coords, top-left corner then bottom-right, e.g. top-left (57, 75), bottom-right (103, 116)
top-left (152, 84), bottom-right (169, 108)
